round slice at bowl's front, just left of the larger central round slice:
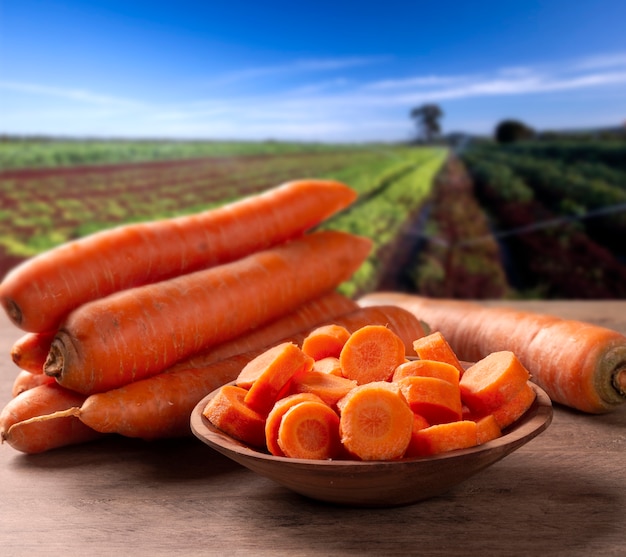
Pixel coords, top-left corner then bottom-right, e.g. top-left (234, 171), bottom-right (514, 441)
top-left (278, 401), bottom-right (341, 460)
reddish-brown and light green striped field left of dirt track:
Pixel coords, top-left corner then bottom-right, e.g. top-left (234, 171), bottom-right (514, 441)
top-left (0, 140), bottom-right (447, 295)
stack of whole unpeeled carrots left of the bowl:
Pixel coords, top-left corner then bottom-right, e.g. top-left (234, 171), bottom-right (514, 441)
top-left (0, 180), bottom-right (423, 453)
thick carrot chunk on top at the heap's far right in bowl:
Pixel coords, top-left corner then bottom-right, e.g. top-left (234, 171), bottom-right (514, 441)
top-left (459, 350), bottom-right (530, 416)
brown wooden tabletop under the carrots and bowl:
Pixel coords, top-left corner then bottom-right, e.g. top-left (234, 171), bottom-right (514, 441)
top-left (0, 301), bottom-right (626, 557)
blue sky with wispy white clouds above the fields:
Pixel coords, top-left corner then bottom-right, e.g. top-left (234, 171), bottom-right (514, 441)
top-left (0, 0), bottom-right (626, 142)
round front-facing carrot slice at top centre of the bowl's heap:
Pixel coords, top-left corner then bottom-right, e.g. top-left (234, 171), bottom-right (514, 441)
top-left (339, 325), bottom-right (406, 385)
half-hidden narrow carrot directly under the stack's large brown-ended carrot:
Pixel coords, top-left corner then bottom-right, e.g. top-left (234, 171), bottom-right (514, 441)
top-left (168, 291), bottom-right (358, 372)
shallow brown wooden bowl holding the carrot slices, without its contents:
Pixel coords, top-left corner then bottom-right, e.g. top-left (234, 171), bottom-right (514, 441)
top-left (190, 385), bottom-right (552, 507)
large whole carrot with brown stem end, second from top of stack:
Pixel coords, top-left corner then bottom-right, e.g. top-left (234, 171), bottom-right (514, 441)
top-left (44, 231), bottom-right (371, 394)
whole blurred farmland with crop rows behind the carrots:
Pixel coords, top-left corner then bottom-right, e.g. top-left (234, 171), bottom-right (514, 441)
top-left (0, 138), bottom-right (626, 299)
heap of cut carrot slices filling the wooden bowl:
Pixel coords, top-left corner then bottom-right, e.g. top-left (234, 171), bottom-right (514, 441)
top-left (203, 323), bottom-right (536, 461)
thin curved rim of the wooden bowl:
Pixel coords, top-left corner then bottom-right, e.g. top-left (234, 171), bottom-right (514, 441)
top-left (190, 381), bottom-right (553, 468)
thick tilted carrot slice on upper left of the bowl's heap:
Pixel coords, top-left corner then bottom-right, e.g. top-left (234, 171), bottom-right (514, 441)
top-left (243, 342), bottom-right (313, 416)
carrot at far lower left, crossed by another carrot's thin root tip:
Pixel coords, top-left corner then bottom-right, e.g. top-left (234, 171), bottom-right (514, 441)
top-left (0, 383), bottom-right (101, 454)
